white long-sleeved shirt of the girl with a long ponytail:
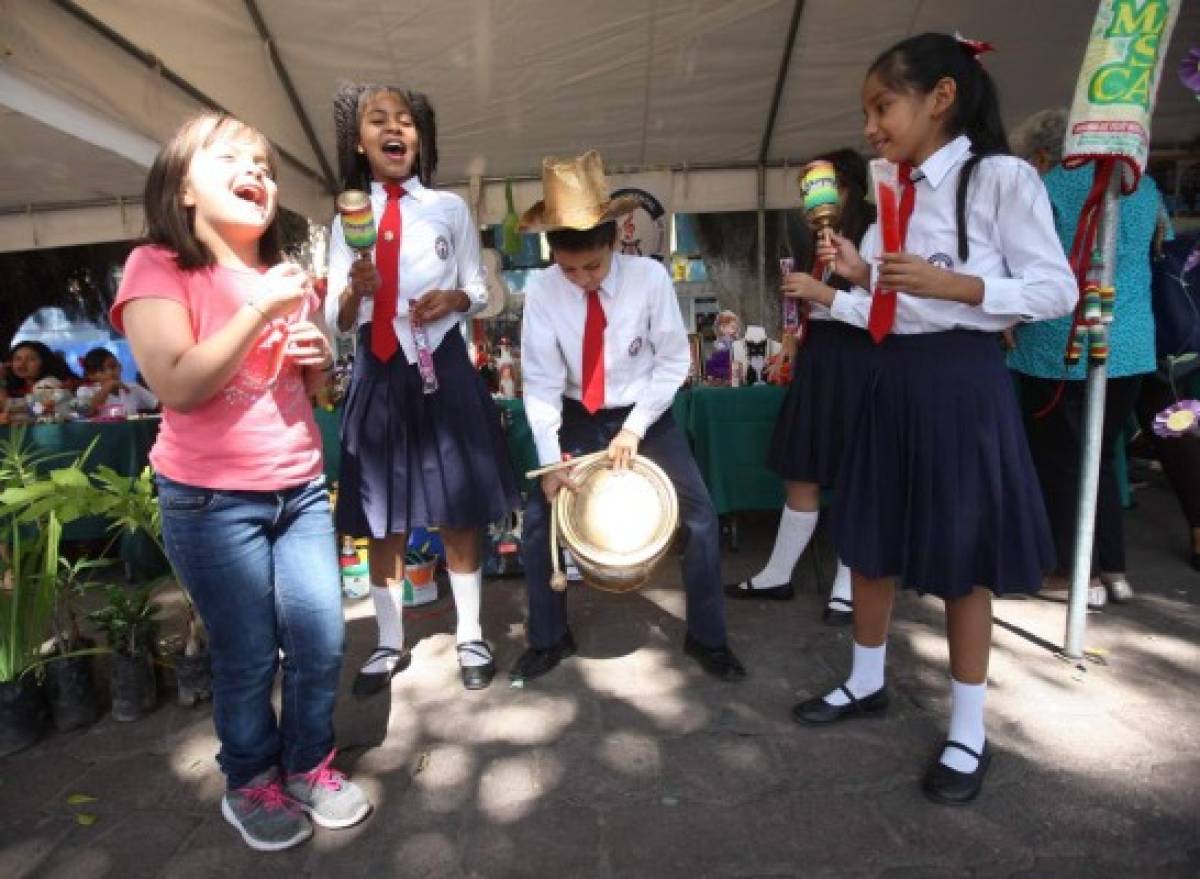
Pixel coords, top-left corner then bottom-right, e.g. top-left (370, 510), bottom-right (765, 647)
top-left (832, 137), bottom-right (1079, 335)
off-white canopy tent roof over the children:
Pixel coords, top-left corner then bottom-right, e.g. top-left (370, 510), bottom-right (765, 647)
top-left (0, 0), bottom-right (1200, 251)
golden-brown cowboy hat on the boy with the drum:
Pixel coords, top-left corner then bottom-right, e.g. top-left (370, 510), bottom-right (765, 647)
top-left (521, 150), bottom-right (637, 232)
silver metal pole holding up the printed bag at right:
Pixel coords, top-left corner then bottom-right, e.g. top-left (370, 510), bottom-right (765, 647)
top-left (1063, 166), bottom-right (1122, 659)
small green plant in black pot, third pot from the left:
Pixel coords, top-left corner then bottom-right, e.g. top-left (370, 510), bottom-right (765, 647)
top-left (89, 584), bottom-right (160, 722)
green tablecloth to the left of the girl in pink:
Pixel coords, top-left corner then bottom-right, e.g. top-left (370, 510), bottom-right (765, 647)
top-left (0, 418), bottom-right (160, 540)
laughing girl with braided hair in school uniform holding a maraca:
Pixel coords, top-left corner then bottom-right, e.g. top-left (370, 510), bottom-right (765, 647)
top-left (325, 84), bottom-right (518, 695)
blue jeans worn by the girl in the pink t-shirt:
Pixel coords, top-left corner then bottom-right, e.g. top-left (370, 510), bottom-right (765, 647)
top-left (158, 476), bottom-right (346, 789)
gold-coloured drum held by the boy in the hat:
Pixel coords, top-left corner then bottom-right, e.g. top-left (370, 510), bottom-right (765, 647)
top-left (552, 455), bottom-right (679, 592)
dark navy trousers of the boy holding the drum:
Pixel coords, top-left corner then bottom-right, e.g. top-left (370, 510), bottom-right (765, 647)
top-left (521, 397), bottom-right (726, 650)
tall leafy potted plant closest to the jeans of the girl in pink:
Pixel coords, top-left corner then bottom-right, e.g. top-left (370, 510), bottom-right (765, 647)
top-left (92, 467), bottom-right (212, 706)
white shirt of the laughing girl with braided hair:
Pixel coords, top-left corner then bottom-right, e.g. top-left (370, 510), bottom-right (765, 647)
top-left (325, 177), bottom-right (487, 363)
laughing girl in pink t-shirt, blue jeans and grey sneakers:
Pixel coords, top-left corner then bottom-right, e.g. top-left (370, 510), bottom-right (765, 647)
top-left (112, 114), bottom-right (371, 851)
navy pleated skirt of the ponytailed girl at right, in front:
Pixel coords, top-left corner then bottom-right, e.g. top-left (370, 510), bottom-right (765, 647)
top-left (834, 330), bottom-right (1055, 598)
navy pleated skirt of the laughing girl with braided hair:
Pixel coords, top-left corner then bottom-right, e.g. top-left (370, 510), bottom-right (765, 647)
top-left (336, 324), bottom-right (520, 538)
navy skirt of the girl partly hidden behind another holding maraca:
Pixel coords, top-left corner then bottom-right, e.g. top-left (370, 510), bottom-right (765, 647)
top-left (767, 321), bottom-right (878, 488)
